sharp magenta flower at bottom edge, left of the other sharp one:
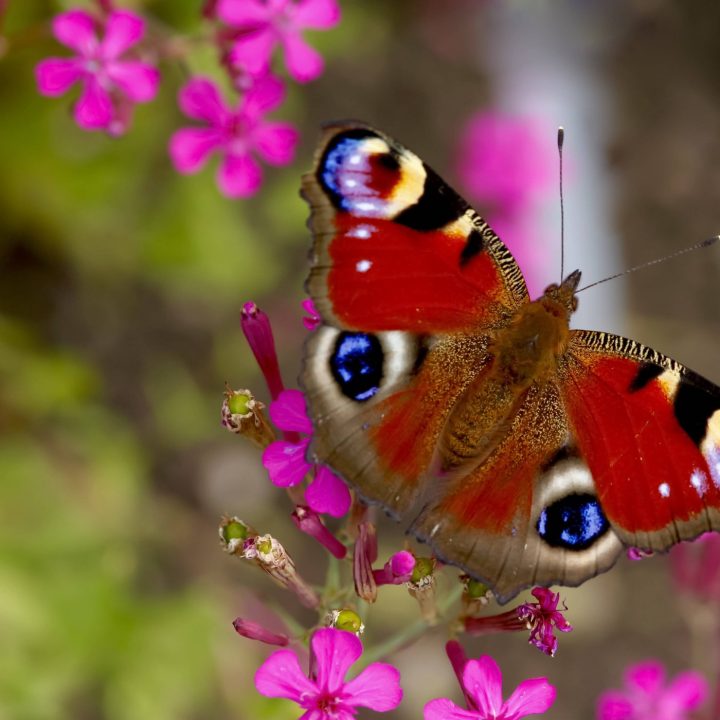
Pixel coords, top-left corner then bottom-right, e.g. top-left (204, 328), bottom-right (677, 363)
top-left (255, 628), bottom-right (403, 720)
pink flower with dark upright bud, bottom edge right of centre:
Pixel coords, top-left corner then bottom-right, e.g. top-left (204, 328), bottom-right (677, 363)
top-left (423, 641), bottom-right (555, 720)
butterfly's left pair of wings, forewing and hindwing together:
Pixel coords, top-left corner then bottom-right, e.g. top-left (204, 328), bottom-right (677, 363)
top-left (301, 123), bottom-right (528, 514)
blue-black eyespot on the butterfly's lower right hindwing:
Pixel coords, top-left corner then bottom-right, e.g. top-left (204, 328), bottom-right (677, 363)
top-left (537, 493), bottom-right (610, 550)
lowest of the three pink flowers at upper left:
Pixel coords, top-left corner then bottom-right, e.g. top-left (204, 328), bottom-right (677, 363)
top-left (170, 76), bottom-right (299, 198)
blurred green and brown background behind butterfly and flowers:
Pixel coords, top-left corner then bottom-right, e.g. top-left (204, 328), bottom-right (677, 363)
top-left (0, 0), bottom-right (720, 720)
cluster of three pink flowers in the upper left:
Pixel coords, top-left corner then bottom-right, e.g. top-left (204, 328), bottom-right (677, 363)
top-left (36, 0), bottom-right (340, 198)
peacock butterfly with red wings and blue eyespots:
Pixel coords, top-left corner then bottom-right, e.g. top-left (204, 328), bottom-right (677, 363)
top-left (301, 122), bottom-right (720, 602)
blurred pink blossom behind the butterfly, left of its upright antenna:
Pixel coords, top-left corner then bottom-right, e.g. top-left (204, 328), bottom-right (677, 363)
top-left (456, 111), bottom-right (557, 296)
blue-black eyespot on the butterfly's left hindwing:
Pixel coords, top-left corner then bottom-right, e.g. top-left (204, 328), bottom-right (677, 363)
top-left (330, 332), bottom-right (383, 402)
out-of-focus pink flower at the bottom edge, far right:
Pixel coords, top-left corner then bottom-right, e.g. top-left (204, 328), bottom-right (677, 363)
top-left (597, 660), bottom-right (708, 720)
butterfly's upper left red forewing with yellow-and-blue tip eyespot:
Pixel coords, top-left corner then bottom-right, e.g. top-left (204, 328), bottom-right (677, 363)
top-left (303, 124), bottom-right (528, 334)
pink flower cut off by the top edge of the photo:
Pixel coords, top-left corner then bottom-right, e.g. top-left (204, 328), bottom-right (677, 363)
top-left (217, 0), bottom-right (340, 82)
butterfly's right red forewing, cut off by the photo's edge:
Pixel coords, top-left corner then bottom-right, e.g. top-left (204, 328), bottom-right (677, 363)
top-left (561, 331), bottom-right (720, 550)
